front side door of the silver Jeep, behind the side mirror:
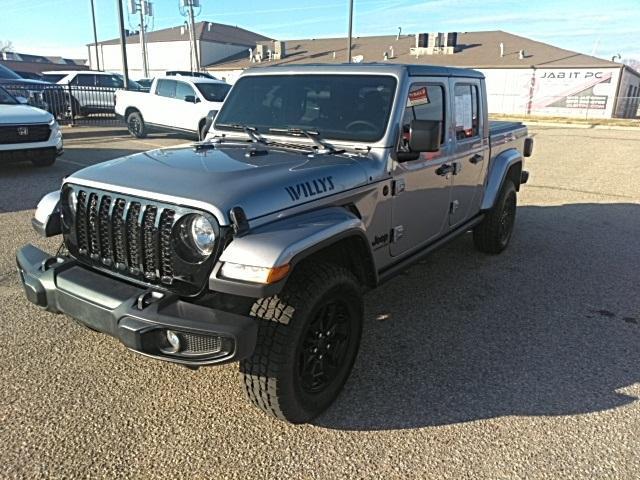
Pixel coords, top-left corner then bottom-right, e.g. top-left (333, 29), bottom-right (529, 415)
top-left (390, 81), bottom-right (452, 256)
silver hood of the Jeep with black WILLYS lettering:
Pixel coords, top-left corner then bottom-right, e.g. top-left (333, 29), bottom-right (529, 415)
top-left (66, 144), bottom-right (368, 225)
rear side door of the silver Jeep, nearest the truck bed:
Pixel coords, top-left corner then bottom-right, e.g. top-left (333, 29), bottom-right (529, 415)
top-left (449, 77), bottom-right (489, 227)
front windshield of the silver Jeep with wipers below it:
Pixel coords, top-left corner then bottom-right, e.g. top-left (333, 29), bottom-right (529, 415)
top-left (216, 74), bottom-right (396, 142)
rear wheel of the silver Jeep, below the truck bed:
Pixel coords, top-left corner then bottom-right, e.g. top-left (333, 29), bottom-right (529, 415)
top-left (473, 179), bottom-right (517, 254)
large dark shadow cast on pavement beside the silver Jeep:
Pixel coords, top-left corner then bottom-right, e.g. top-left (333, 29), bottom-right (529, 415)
top-left (315, 204), bottom-right (640, 430)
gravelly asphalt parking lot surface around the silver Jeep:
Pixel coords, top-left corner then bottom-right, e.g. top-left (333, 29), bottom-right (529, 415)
top-left (0, 127), bottom-right (640, 479)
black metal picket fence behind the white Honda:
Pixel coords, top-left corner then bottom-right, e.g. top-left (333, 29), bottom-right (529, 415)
top-left (0, 84), bottom-right (124, 125)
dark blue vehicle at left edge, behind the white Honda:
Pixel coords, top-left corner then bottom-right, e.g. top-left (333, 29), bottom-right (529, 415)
top-left (0, 64), bottom-right (65, 115)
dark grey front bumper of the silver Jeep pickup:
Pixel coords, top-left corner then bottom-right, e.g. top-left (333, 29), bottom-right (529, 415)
top-left (16, 245), bottom-right (257, 367)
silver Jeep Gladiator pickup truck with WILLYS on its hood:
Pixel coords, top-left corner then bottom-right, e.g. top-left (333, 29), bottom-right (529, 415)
top-left (17, 64), bottom-right (533, 423)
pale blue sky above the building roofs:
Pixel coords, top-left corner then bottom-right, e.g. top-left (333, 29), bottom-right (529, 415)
top-left (0, 0), bottom-right (640, 60)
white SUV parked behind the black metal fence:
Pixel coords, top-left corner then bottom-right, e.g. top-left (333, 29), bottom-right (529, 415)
top-left (42, 70), bottom-right (142, 116)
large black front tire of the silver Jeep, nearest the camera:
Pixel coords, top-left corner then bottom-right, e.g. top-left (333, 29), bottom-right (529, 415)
top-left (240, 262), bottom-right (363, 423)
